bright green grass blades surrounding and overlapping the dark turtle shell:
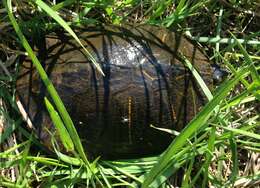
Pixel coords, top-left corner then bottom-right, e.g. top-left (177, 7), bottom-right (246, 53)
top-left (0, 0), bottom-right (260, 188)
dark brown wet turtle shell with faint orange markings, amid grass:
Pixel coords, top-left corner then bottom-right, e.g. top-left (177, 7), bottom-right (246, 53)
top-left (17, 25), bottom-right (212, 158)
